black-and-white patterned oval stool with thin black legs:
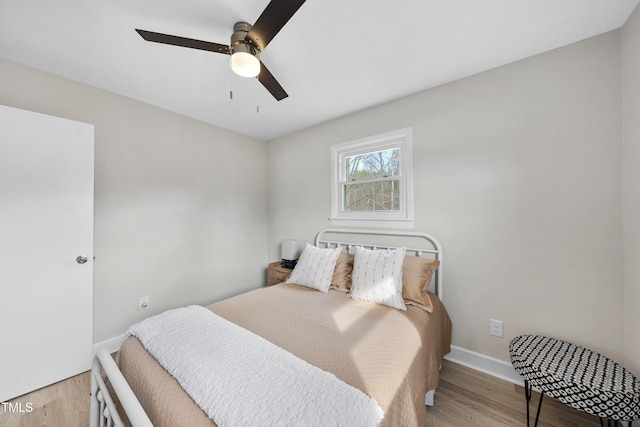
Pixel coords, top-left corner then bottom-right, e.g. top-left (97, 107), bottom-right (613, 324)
top-left (509, 335), bottom-right (640, 426)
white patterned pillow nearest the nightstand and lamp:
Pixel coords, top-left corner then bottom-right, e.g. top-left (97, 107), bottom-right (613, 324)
top-left (287, 243), bottom-right (342, 292)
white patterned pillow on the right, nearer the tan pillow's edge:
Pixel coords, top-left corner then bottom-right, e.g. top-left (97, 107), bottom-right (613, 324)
top-left (349, 246), bottom-right (407, 310)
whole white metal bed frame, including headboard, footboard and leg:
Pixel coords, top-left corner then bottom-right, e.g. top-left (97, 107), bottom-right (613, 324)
top-left (89, 228), bottom-right (443, 427)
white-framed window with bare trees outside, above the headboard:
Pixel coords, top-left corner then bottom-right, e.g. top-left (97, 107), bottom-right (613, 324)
top-left (330, 128), bottom-right (413, 227)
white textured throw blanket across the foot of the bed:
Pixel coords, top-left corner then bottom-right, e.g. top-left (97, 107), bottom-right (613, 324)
top-left (126, 306), bottom-right (383, 427)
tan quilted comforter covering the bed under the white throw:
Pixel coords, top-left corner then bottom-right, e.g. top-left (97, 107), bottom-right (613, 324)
top-left (118, 283), bottom-right (451, 427)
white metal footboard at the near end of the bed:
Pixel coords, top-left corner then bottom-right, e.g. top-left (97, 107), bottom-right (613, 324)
top-left (89, 350), bottom-right (153, 427)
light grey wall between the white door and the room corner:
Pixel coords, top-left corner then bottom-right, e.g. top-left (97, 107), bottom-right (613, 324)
top-left (0, 60), bottom-right (267, 342)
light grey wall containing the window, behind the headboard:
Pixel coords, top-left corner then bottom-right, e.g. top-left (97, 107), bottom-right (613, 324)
top-left (268, 31), bottom-right (623, 360)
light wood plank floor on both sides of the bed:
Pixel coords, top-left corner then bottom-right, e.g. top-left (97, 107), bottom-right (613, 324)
top-left (0, 360), bottom-right (616, 427)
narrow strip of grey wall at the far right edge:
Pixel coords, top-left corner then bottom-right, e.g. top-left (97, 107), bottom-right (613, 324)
top-left (622, 7), bottom-right (640, 375)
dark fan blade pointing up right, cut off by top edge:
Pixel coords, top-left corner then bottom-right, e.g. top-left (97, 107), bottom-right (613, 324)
top-left (248, 0), bottom-right (305, 51)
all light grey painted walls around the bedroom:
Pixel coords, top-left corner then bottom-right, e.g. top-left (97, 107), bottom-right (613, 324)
top-left (0, 10), bottom-right (640, 372)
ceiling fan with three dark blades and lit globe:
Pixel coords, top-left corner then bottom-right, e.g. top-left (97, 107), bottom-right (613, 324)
top-left (136, 0), bottom-right (305, 101)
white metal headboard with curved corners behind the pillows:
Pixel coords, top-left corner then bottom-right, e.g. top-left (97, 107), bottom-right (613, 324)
top-left (315, 228), bottom-right (444, 300)
